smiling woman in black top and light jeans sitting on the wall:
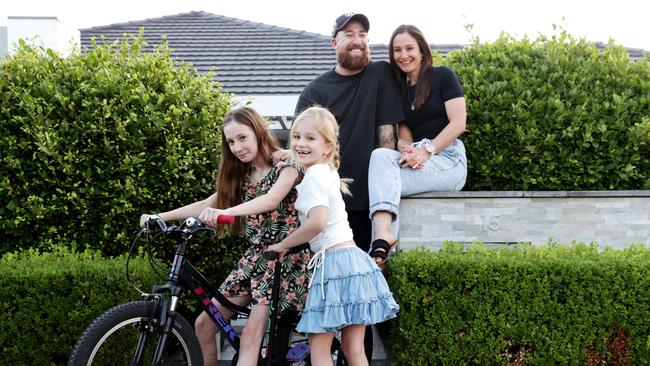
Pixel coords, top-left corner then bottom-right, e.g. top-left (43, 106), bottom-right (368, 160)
top-left (368, 25), bottom-right (467, 266)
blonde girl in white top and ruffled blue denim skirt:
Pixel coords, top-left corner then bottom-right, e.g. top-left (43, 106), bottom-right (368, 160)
top-left (268, 107), bottom-right (399, 365)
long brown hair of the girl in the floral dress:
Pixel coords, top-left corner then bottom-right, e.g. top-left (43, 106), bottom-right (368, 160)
top-left (216, 107), bottom-right (280, 234)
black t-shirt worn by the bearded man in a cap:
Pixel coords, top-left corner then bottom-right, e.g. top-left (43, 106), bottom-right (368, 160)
top-left (296, 62), bottom-right (404, 211)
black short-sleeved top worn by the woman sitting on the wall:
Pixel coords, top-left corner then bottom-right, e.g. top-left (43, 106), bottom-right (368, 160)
top-left (402, 66), bottom-right (463, 141)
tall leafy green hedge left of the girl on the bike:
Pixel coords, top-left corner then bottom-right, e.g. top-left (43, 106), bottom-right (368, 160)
top-left (0, 35), bottom-right (230, 256)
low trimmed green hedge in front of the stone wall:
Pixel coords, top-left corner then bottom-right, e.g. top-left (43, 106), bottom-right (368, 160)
top-left (389, 243), bottom-right (650, 365)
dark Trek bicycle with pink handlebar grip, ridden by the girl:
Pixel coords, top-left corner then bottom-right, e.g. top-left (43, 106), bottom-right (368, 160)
top-left (68, 216), bottom-right (342, 366)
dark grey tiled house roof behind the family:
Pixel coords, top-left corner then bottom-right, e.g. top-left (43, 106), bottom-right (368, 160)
top-left (80, 11), bottom-right (463, 95)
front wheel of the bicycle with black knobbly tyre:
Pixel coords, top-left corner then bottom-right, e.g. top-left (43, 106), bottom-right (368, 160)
top-left (68, 301), bottom-right (203, 366)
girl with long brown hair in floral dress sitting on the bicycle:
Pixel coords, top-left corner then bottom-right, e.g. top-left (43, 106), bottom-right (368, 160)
top-left (140, 107), bottom-right (310, 365)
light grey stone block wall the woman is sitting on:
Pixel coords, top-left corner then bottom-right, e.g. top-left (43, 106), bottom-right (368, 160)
top-left (399, 190), bottom-right (650, 250)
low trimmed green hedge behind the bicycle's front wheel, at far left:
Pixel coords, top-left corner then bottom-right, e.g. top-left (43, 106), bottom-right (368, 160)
top-left (0, 247), bottom-right (157, 365)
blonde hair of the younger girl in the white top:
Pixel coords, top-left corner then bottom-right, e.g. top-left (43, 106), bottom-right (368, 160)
top-left (289, 106), bottom-right (352, 195)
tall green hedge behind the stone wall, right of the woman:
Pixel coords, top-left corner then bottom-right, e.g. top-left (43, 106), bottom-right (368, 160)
top-left (436, 31), bottom-right (650, 190)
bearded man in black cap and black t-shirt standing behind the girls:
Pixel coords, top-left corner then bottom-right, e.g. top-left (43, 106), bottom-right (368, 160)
top-left (296, 13), bottom-right (404, 251)
